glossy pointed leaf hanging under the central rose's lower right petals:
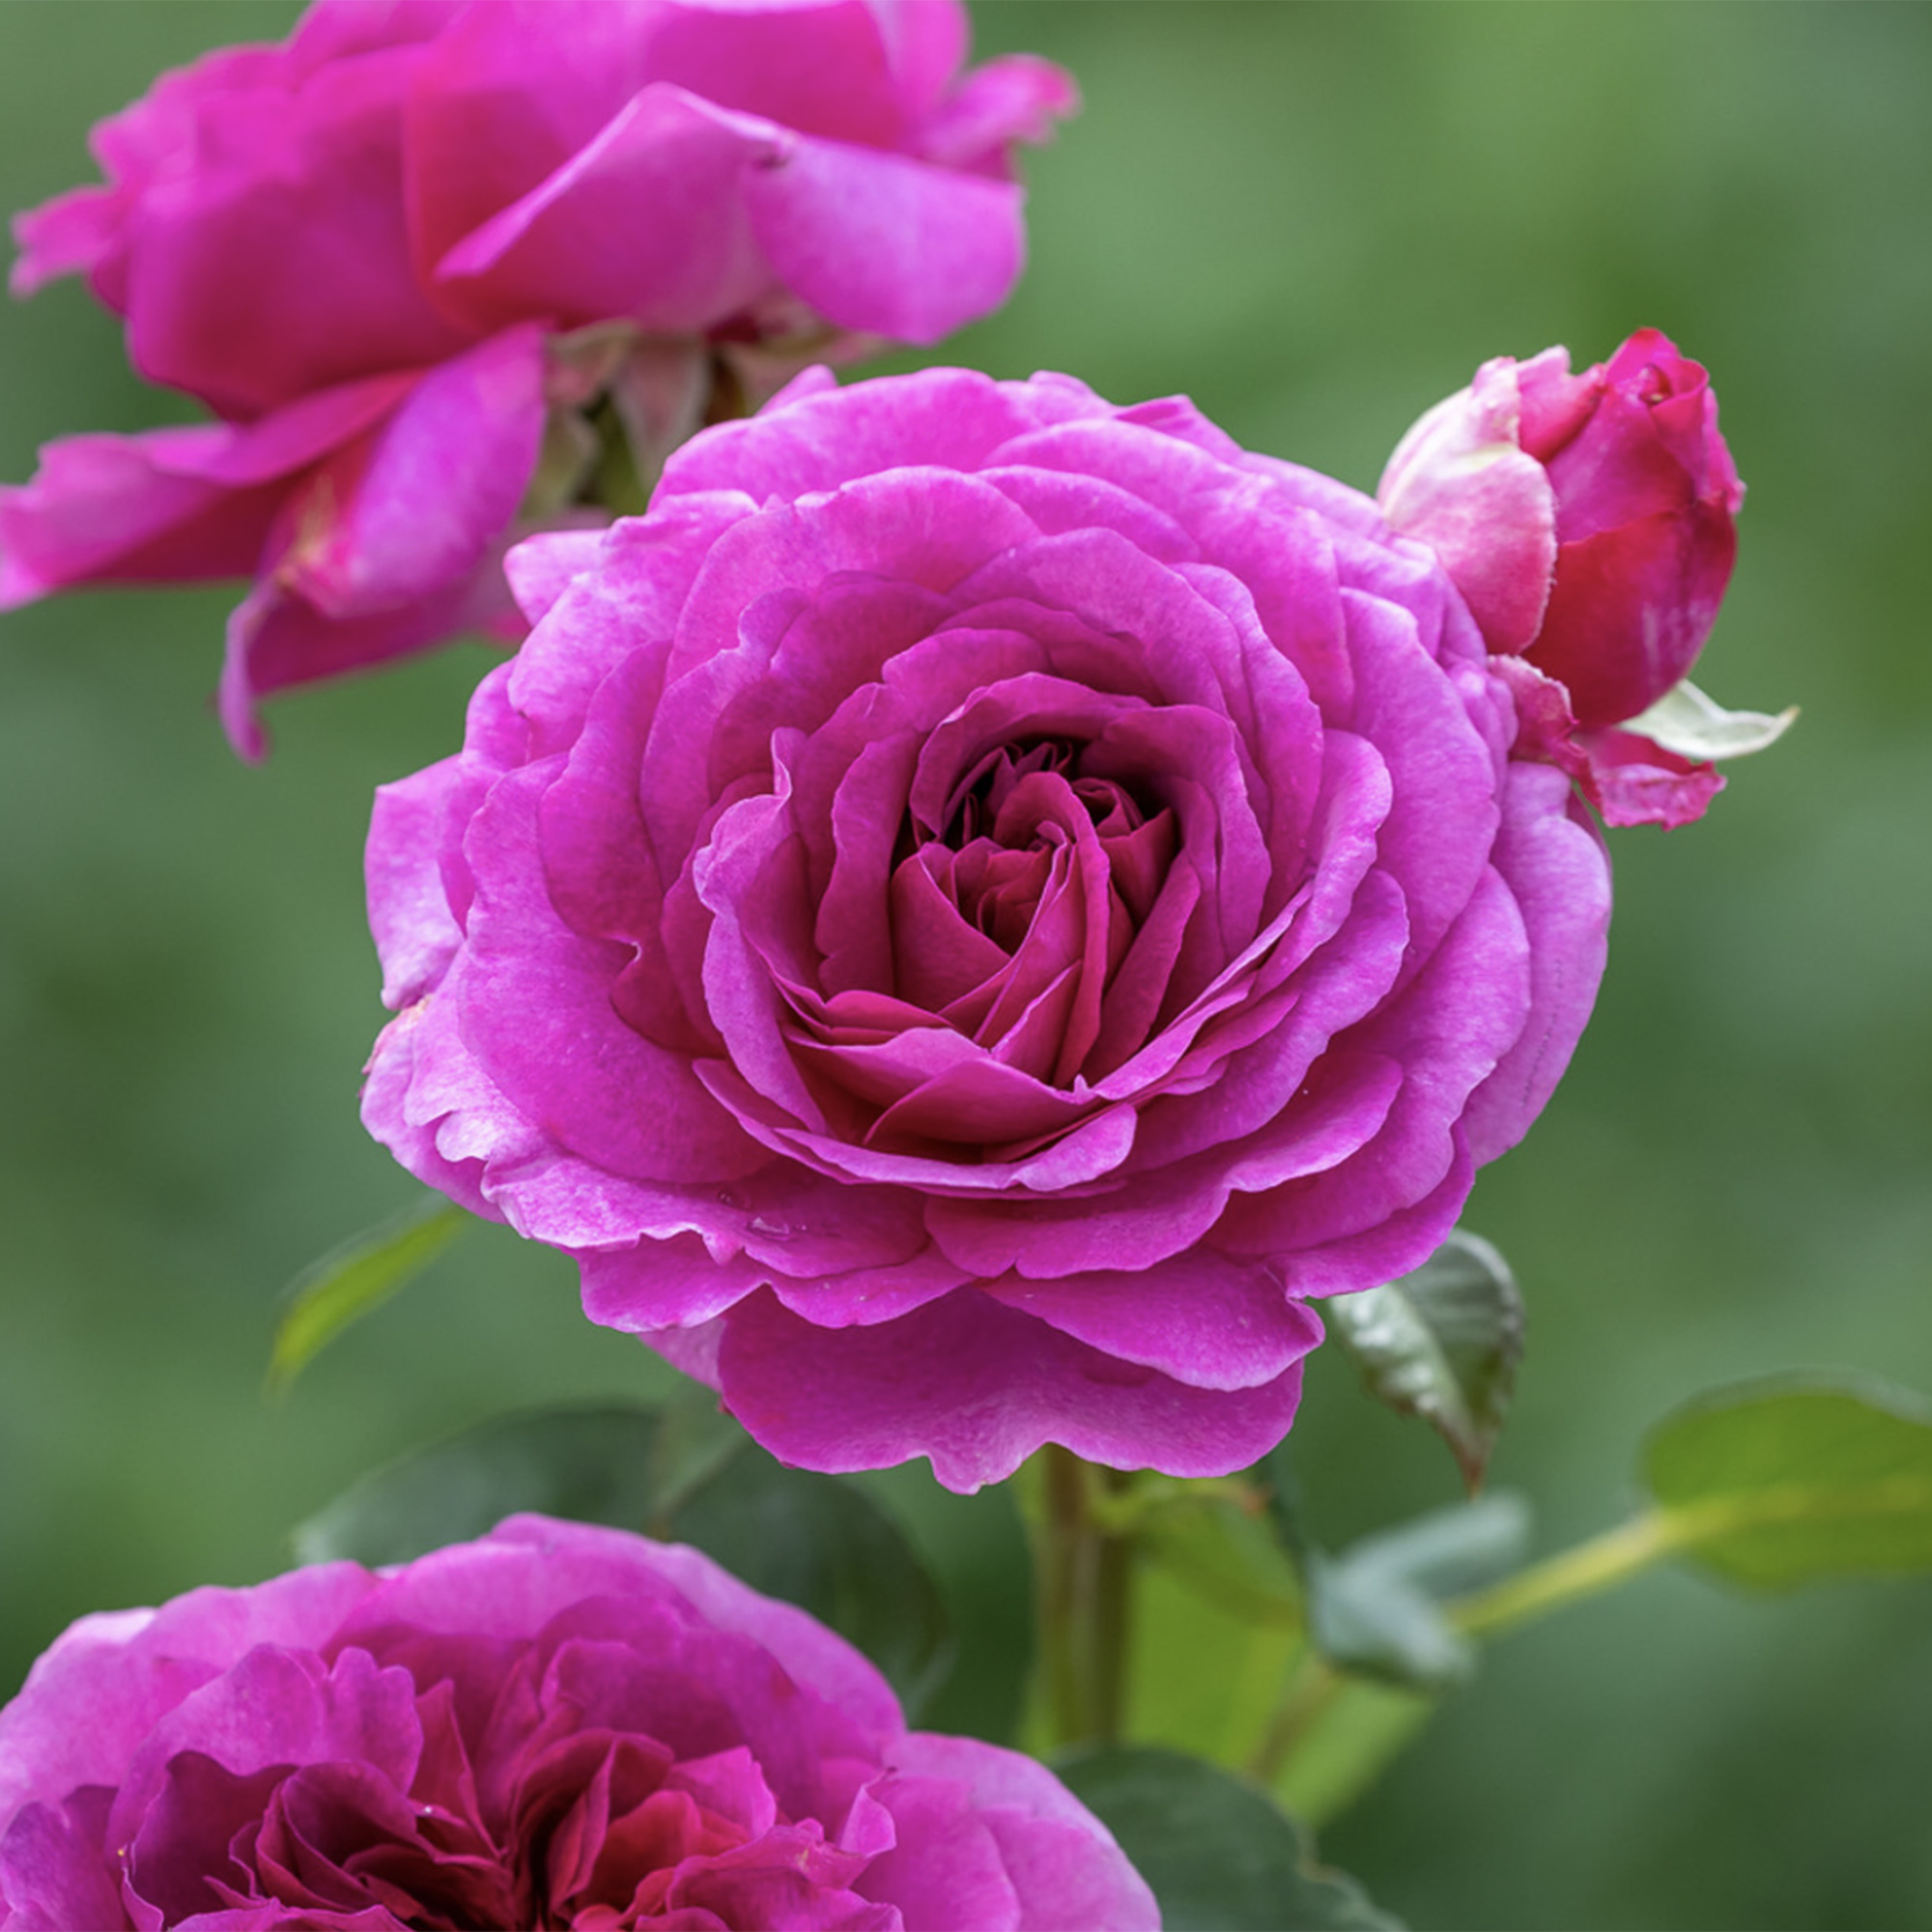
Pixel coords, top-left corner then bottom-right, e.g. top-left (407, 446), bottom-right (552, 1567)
top-left (1323, 1229), bottom-right (1522, 1492)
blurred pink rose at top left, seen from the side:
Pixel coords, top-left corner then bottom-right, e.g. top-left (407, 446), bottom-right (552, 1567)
top-left (0, 0), bottom-right (1074, 753)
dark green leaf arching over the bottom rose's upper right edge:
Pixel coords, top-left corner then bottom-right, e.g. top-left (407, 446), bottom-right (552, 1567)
top-left (667, 1447), bottom-right (952, 1718)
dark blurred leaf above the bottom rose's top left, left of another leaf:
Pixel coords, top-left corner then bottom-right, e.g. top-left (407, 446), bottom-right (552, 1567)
top-left (296, 1406), bottom-right (657, 1569)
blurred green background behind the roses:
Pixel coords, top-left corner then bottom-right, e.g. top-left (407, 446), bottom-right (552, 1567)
top-left (0, 0), bottom-right (1932, 1928)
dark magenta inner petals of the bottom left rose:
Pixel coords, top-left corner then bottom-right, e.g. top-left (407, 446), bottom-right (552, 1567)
top-left (109, 1638), bottom-right (866, 1932)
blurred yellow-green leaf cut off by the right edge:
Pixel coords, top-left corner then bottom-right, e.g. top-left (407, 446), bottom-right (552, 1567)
top-left (1644, 1379), bottom-right (1932, 1590)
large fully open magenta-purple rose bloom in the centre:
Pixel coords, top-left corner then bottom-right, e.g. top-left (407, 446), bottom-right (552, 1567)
top-left (363, 369), bottom-right (1609, 1488)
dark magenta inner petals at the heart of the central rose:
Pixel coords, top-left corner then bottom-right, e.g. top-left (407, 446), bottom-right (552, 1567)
top-left (738, 672), bottom-right (1298, 1161)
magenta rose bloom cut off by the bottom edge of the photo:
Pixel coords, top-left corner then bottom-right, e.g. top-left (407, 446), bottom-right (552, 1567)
top-left (0, 1517), bottom-right (1159, 1932)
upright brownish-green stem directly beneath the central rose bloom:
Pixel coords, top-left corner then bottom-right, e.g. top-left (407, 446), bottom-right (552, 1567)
top-left (1039, 1443), bottom-right (1134, 1745)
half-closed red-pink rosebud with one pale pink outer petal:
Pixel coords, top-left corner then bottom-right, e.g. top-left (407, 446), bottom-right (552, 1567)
top-left (1379, 328), bottom-right (1745, 825)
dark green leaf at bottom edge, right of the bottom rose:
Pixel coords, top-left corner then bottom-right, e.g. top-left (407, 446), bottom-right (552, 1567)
top-left (1053, 1745), bottom-right (1401, 1932)
